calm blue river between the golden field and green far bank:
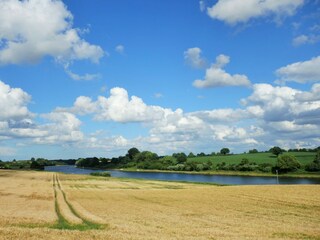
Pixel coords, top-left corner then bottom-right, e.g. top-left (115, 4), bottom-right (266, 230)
top-left (45, 165), bottom-right (320, 185)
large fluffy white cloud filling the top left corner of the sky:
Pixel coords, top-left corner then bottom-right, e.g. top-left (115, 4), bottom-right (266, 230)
top-left (0, 0), bottom-right (104, 64)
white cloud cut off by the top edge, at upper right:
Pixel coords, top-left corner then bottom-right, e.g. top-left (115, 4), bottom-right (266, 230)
top-left (207, 0), bottom-right (304, 25)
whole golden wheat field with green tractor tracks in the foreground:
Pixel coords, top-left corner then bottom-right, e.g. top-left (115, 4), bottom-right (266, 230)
top-left (0, 170), bottom-right (320, 240)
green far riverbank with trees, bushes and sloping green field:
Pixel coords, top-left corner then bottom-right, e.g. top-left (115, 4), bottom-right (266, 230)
top-left (76, 148), bottom-right (320, 177)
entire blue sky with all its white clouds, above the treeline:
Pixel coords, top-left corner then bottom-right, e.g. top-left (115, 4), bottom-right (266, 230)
top-left (0, 0), bottom-right (320, 160)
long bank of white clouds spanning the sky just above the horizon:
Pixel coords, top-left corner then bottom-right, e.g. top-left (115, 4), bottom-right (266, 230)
top-left (0, 79), bottom-right (320, 155)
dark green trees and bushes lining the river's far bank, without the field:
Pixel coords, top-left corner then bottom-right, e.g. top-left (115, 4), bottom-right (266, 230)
top-left (76, 147), bottom-right (320, 173)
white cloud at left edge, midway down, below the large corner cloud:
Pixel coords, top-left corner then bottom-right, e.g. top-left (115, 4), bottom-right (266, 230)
top-left (0, 81), bottom-right (83, 144)
